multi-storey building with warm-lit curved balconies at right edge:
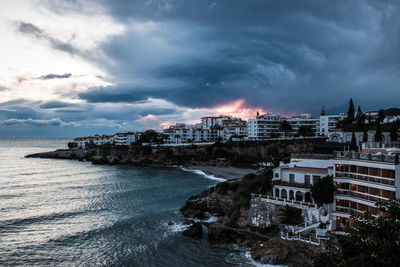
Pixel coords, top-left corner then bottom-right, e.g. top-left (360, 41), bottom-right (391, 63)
top-left (332, 143), bottom-right (400, 230)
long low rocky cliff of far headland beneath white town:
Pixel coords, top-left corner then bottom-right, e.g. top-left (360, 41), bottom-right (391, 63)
top-left (27, 138), bottom-right (338, 168)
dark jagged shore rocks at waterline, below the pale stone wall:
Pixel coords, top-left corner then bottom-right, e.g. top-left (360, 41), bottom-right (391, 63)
top-left (180, 179), bottom-right (317, 265)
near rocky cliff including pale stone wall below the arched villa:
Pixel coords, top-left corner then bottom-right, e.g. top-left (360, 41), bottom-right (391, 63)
top-left (180, 174), bottom-right (316, 264)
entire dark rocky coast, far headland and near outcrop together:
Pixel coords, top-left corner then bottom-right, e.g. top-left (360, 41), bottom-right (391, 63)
top-left (26, 141), bottom-right (332, 265)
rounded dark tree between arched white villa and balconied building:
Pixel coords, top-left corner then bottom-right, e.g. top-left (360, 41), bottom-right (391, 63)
top-left (311, 175), bottom-right (336, 204)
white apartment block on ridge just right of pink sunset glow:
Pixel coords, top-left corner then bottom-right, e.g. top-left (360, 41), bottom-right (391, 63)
top-left (247, 112), bottom-right (281, 140)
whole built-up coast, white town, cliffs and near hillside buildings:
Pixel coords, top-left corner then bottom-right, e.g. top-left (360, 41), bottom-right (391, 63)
top-left (28, 99), bottom-right (400, 264)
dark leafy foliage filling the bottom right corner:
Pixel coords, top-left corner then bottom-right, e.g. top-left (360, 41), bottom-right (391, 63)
top-left (314, 199), bottom-right (400, 267)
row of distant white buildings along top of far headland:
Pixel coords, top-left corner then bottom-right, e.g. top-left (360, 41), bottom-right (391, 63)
top-left (69, 101), bottom-right (400, 148)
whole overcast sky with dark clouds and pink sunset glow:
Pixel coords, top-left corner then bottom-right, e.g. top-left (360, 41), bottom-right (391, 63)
top-left (0, 0), bottom-right (400, 136)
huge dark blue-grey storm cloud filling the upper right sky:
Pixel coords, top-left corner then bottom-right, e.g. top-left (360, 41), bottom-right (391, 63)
top-left (77, 0), bottom-right (400, 113)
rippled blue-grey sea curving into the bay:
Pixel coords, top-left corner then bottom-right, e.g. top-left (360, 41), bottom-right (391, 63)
top-left (0, 137), bottom-right (268, 267)
